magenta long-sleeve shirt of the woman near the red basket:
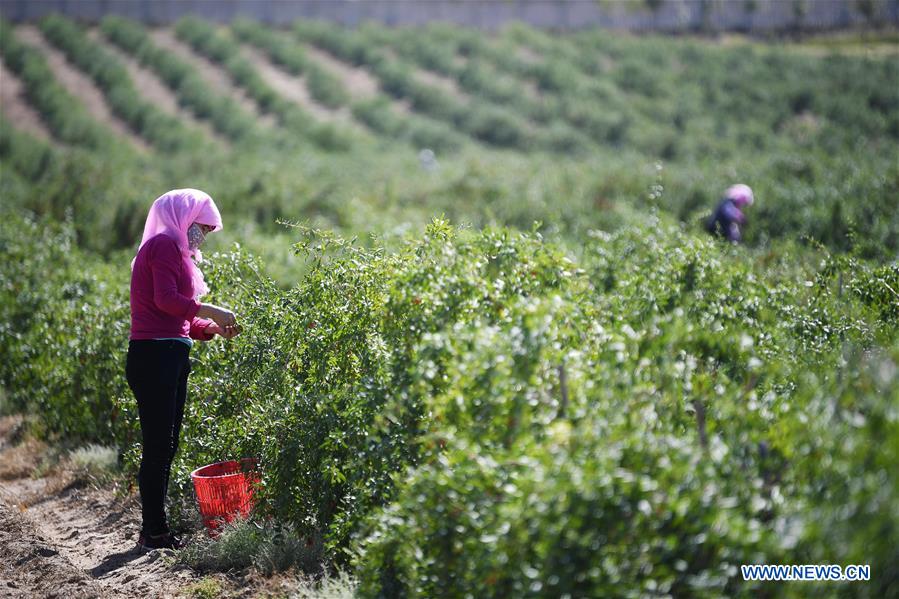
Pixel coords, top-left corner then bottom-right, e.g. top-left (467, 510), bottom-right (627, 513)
top-left (131, 234), bottom-right (213, 341)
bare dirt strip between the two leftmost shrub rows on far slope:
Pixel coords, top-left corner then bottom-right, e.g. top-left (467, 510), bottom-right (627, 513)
top-left (16, 25), bottom-right (150, 152)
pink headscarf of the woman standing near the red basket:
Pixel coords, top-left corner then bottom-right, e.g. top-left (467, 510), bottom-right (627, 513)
top-left (131, 189), bottom-right (222, 299)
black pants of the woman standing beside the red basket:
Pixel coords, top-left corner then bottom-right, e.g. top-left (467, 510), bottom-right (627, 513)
top-left (125, 340), bottom-right (190, 535)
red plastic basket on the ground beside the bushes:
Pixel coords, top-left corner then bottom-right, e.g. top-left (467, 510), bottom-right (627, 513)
top-left (190, 458), bottom-right (259, 536)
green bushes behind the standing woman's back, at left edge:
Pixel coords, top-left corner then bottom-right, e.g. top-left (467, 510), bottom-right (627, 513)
top-left (0, 209), bottom-right (133, 446)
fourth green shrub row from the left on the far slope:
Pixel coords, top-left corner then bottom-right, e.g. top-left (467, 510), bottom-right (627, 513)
top-left (175, 17), bottom-right (353, 150)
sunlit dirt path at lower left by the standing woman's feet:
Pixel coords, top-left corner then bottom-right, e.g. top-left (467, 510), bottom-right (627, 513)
top-left (0, 418), bottom-right (198, 599)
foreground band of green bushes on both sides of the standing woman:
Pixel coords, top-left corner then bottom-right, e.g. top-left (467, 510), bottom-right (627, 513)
top-left (0, 207), bottom-right (899, 597)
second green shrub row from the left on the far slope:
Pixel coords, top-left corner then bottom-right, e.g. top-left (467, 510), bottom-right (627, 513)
top-left (40, 15), bottom-right (199, 150)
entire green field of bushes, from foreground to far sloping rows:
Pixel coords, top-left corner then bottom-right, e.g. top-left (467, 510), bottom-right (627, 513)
top-left (0, 16), bottom-right (899, 597)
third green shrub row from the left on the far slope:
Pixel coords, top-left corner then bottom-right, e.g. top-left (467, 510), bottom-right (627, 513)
top-left (100, 16), bottom-right (255, 141)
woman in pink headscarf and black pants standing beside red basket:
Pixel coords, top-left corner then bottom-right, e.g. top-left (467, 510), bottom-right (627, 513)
top-left (125, 189), bottom-right (240, 549)
